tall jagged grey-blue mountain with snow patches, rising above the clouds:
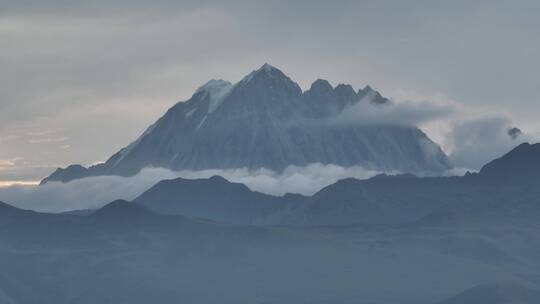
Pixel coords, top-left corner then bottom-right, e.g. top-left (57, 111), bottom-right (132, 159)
top-left (43, 64), bottom-right (450, 182)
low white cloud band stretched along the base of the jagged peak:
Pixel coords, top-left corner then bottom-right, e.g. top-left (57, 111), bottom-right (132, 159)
top-left (0, 164), bottom-right (378, 212)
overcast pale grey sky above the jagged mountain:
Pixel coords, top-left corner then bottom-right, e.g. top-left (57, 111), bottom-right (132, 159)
top-left (0, 0), bottom-right (540, 180)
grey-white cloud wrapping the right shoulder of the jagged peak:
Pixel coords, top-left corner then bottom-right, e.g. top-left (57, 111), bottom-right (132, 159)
top-left (330, 94), bottom-right (538, 172)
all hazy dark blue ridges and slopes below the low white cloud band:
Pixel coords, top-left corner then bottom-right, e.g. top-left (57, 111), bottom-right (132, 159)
top-left (0, 144), bottom-right (540, 304)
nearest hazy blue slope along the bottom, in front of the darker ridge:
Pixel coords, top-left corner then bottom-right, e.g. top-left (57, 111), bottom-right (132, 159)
top-left (0, 196), bottom-right (540, 304)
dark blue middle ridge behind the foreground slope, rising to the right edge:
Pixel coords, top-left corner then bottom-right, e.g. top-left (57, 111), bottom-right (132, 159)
top-left (134, 144), bottom-right (540, 225)
